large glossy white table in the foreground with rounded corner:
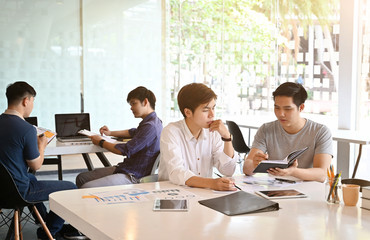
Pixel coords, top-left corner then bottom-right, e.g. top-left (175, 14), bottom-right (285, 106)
top-left (49, 176), bottom-right (370, 240)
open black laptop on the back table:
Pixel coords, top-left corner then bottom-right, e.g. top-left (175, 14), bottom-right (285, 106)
top-left (55, 113), bottom-right (91, 142)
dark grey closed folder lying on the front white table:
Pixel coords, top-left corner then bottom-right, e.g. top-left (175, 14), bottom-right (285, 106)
top-left (199, 191), bottom-right (279, 216)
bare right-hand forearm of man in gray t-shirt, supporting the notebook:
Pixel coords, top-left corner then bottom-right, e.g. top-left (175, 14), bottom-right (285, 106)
top-left (268, 153), bottom-right (332, 182)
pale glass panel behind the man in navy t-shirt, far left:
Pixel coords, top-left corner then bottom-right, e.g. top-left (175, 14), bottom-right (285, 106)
top-left (0, 0), bottom-right (81, 129)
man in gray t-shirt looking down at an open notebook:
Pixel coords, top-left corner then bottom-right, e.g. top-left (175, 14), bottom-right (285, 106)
top-left (243, 82), bottom-right (333, 182)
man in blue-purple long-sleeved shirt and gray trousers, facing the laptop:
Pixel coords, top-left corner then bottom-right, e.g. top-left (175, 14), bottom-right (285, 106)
top-left (76, 87), bottom-right (163, 188)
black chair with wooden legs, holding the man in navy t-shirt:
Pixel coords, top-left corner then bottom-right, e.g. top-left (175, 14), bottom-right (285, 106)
top-left (0, 162), bottom-right (53, 240)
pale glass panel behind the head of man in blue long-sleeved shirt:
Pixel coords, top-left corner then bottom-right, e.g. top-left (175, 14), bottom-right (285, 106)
top-left (82, 0), bottom-right (162, 131)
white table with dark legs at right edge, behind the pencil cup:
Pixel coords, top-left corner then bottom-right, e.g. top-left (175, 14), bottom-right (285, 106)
top-left (333, 130), bottom-right (370, 178)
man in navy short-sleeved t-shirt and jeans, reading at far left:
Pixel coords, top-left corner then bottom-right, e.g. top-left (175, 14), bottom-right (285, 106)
top-left (0, 82), bottom-right (86, 239)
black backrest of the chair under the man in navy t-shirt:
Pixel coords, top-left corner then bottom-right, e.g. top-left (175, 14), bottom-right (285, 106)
top-left (0, 162), bottom-right (32, 209)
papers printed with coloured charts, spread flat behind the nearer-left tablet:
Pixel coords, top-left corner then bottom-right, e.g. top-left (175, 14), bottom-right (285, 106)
top-left (82, 188), bottom-right (195, 204)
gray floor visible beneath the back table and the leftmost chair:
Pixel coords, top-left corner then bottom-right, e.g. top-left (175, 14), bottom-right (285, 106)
top-left (0, 169), bottom-right (81, 240)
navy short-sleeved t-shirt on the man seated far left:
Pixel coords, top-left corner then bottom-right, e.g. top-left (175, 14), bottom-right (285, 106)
top-left (0, 114), bottom-right (40, 196)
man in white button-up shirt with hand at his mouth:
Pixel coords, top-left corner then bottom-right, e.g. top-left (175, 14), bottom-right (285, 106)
top-left (159, 83), bottom-right (237, 191)
